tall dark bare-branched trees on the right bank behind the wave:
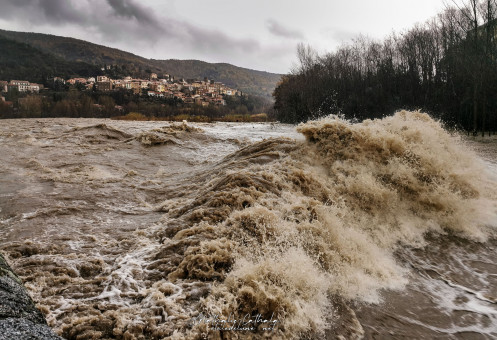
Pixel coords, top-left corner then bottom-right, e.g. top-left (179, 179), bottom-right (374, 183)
top-left (274, 0), bottom-right (497, 132)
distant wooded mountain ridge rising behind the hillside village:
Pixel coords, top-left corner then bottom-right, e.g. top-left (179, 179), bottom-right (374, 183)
top-left (0, 30), bottom-right (281, 97)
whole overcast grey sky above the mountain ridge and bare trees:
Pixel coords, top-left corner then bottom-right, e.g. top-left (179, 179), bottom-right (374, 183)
top-left (0, 0), bottom-right (444, 73)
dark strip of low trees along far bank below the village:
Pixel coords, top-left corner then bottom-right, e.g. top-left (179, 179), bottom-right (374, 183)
top-left (0, 84), bottom-right (272, 119)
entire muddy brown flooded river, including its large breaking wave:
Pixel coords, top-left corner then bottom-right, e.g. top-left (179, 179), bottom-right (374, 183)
top-left (0, 112), bottom-right (497, 339)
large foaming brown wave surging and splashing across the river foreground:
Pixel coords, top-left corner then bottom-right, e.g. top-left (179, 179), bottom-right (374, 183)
top-left (0, 111), bottom-right (497, 339)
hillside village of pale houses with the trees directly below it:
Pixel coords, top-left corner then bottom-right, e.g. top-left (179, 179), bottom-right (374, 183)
top-left (0, 69), bottom-right (272, 121)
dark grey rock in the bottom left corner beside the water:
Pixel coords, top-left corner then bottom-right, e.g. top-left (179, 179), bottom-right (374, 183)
top-left (0, 254), bottom-right (62, 340)
